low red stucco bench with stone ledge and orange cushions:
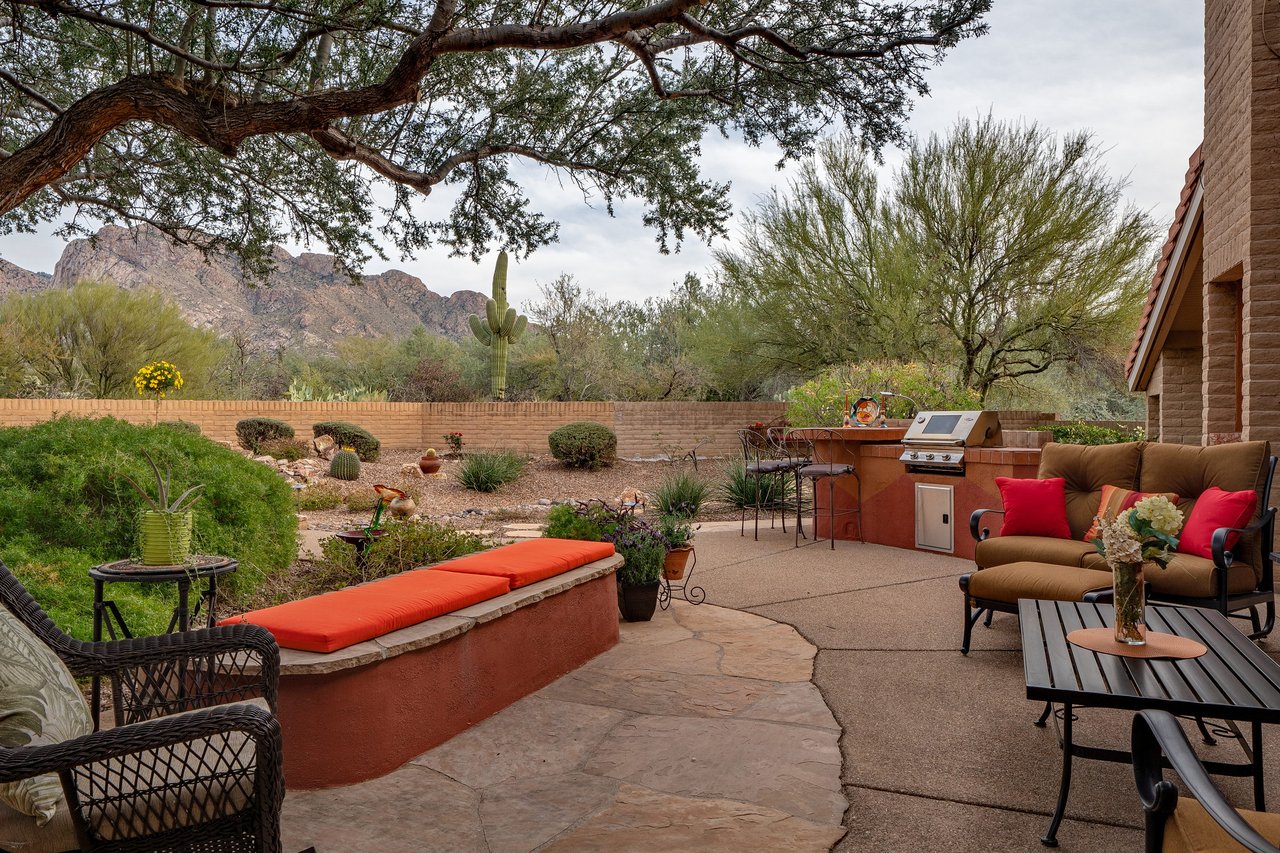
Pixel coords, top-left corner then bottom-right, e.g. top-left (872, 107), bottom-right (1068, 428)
top-left (223, 538), bottom-right (622, 789)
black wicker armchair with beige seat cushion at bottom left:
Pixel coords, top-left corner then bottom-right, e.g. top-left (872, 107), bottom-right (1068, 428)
top-left (0, 562), bottom-right (284, 853)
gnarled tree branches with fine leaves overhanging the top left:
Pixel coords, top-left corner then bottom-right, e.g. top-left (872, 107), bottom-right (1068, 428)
top-left (0, 0), bottom-right (989, 269)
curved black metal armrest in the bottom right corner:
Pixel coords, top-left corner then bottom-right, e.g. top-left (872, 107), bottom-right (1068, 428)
top-left (1133, 711), bottom-right (1280, 853)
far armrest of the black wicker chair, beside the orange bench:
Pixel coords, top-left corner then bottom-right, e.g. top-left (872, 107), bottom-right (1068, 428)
top-left (67, 624), bottom-right (280, 722)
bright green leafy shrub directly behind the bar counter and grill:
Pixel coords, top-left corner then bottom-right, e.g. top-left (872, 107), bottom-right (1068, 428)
top-left (786, 361), bottom-right (982, 427)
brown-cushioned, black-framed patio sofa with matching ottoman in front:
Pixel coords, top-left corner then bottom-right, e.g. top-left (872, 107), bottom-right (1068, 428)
top-left (960, 442), bottom-right (1276, 652)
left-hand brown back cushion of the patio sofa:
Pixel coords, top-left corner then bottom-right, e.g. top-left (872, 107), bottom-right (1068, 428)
top-left (1028, 442), bottom-right (1146, 535)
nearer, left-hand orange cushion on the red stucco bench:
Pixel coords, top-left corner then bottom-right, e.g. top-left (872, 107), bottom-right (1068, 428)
top-left (219, 569), bottom-right (511, 652)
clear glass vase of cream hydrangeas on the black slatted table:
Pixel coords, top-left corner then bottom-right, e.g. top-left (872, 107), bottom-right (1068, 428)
top-left (1093, 494), bottom-right (1183, 646)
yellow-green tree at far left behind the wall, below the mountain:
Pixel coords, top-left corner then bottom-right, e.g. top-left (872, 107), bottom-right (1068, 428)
top-left (0, 282), bottom-right (224, 398)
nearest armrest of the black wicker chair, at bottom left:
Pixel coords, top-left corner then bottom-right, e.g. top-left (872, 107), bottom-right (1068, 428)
top-left (0, 703), bottom-right (280, 783)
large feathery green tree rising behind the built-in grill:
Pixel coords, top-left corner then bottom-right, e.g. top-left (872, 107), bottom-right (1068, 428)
top-left (719, 118), bottom-right (1155, 398)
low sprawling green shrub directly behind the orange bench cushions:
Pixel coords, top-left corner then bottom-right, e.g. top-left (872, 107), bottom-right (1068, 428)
top-left (290, 519), bottom-right (489, 591)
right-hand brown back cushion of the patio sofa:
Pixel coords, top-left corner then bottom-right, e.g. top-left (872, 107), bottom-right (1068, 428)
top-left (1138, 442), bottom-right (1271, 583)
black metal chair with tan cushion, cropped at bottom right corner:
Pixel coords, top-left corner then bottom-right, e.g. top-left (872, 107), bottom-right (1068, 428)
top-left (1133, 711), bottom-right (1280, 853)
